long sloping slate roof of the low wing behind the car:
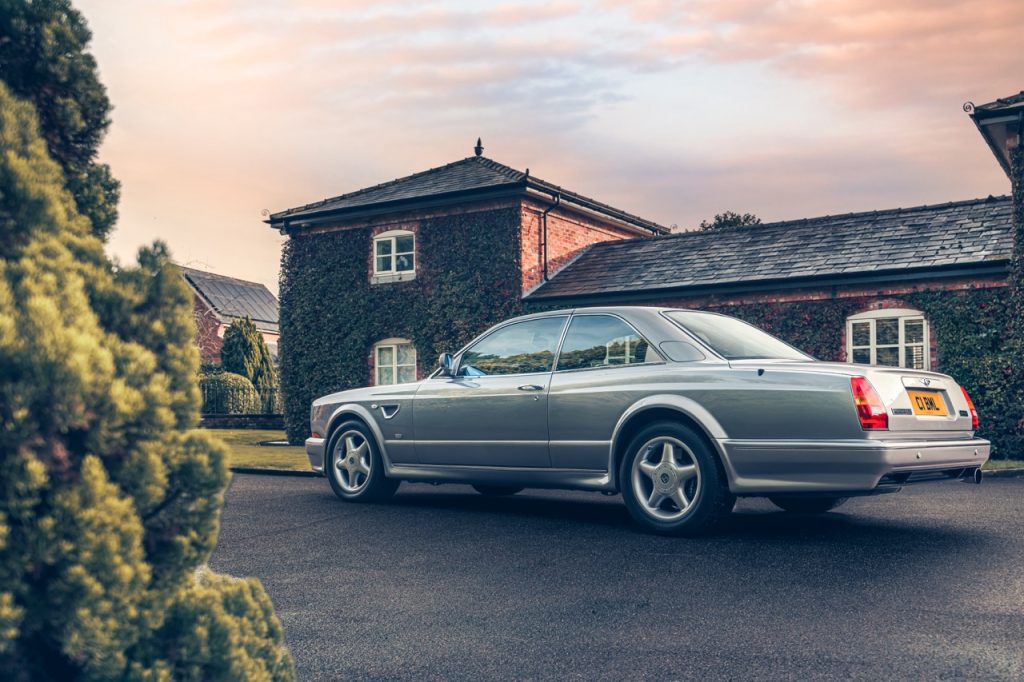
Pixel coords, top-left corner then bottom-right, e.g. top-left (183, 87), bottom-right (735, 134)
top-left (526, 197), bottom-right (1013, 302)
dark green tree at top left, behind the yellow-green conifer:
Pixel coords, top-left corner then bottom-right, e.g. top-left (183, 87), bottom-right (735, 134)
top-left (0, 0), bottom-right (121, 240)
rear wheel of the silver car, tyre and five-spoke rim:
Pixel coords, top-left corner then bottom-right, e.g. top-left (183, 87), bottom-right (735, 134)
top-left (618, 422), bottom-right (736, 536)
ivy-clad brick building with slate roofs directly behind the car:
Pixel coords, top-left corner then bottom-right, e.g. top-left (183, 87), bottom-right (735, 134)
top-left (267, 140), bottom-right (1017, 448)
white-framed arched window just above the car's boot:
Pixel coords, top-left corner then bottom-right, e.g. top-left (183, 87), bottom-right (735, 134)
top-left (846, 308), bottom-right (931, 370)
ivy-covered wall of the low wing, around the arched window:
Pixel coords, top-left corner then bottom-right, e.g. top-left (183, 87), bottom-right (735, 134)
top-left (707, 287), bottom-right (1024, 459)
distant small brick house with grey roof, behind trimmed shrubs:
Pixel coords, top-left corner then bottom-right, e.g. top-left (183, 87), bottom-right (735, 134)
top-left (181, 267), bottom-right (280, 363)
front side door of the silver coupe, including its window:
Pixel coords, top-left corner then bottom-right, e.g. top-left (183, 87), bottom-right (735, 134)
top-left (413, 315), bottom-right (568, 467)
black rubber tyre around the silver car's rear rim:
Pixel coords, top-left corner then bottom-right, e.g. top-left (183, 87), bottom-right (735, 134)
top-left (618, 422), bottom-right (735, 536)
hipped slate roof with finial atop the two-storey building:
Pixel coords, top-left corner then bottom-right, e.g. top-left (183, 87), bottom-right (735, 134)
top-left (266, 157), bottom-right (669, 233)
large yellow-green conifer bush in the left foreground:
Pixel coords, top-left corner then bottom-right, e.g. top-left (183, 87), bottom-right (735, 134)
top-left (0, 82), bottom-right (294, 682)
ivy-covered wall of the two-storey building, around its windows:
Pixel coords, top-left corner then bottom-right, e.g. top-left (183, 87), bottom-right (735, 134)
top-left (279, 204), bottom-right (521, 443)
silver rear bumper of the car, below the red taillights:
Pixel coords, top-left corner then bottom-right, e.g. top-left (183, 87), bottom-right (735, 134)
top-left (718, 438), bottom-right (990, 495)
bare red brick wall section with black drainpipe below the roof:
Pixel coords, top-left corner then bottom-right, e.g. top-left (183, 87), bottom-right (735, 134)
top-left (519, 200), bottom-right (640, 294)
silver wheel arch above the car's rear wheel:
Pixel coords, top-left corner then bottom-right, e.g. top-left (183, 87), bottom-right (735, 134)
top-left (608, 395), bottom-right (735, 489)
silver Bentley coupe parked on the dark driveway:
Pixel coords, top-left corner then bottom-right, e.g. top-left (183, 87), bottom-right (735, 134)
top-left (306, 306), bottom-right (989, 535)
